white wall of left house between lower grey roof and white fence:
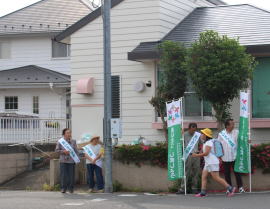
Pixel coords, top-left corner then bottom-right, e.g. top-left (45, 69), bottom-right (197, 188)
top-left (0, 89), bottom-right (66, 118)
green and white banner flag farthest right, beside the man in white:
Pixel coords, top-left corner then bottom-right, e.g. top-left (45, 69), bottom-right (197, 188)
top-left (234, 92), bottom-right (250, 173)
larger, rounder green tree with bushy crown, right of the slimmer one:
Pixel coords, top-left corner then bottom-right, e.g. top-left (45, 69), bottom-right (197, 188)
top-left (187, 31), bottom-right (256, 129)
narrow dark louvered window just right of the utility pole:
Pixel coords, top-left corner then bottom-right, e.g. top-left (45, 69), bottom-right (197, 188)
top-left (111, 76), bottom-right (120, 118)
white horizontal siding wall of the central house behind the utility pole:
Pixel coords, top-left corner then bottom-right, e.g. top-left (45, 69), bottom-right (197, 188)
top-left (71, 0), bottom-right (216, 143)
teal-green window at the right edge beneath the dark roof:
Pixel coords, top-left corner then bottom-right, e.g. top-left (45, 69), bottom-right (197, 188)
top-left (252, 57), bottom-right (270, 118)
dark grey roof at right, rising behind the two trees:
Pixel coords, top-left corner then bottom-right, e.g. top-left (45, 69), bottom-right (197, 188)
top-left (128, 4), bottom-right (270, 60)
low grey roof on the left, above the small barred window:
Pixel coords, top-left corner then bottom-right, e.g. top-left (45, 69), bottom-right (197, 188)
top-left (0, 65), bottom-right (70, 86)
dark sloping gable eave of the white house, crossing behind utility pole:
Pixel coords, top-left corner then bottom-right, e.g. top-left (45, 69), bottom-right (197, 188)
top-left (55, 0), bottom-right (124, 41)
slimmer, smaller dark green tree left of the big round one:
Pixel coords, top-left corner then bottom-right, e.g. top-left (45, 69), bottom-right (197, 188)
top-left (150, 41), bottom-right (187, 139)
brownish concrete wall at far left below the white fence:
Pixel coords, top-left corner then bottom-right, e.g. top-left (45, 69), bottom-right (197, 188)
top-left (0, 146), bottom-right (29, 184)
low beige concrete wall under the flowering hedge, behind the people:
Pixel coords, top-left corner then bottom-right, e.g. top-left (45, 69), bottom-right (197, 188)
top-left (50, 160), bottom-right (270, 192)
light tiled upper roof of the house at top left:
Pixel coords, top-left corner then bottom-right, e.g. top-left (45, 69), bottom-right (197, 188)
top-left (0, 0), bottom-right (91, 35)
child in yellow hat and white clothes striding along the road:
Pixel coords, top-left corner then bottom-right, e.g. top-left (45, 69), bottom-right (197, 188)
top-left (192, 128), bottom-right (235, 197)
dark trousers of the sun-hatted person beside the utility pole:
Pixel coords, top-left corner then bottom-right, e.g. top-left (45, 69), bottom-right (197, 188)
top-left (87, 164), bottom-right (104, 190)
